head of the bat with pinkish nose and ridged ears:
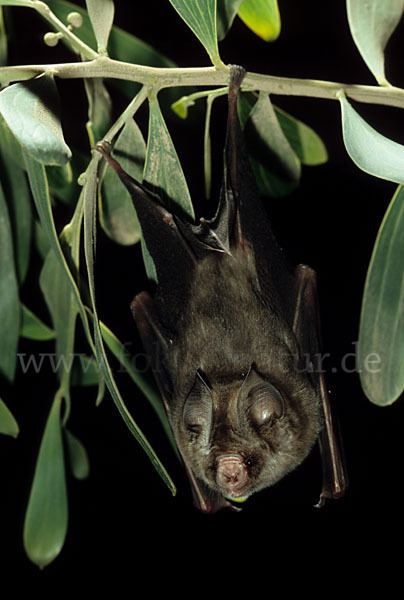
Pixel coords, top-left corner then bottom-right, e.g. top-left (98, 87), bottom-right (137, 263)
top-left (172, 365), bottom-right (319, 501)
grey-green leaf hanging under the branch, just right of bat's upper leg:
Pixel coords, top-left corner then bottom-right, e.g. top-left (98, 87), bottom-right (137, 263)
top-left (239, 93), bottom-right (301, 197)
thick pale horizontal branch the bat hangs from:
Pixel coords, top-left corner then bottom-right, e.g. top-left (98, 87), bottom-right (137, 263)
top-left (0, 56), bottom-right (404, 108)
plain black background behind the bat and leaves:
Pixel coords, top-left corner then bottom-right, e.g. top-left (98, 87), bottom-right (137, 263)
top-left (0, 0), bottom-right (404, 593)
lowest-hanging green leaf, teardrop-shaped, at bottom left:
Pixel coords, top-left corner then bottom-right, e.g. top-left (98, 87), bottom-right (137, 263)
top-left (24, 395), bottom-right (68, 568)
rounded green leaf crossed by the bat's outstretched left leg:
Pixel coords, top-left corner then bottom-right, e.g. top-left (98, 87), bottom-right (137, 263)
top-left (100, 119), bottom-right (146, 245)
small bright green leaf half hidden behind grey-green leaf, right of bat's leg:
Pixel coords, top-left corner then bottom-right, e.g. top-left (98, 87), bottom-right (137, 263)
top-left (274, 106), bottom-right (328, 166)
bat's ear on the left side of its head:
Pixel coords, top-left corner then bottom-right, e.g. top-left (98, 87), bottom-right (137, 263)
top-left (182, 371), bottom-right (213, 446)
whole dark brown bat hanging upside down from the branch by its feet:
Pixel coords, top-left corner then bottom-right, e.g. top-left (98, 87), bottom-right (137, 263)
top-left (97, 66), bottom-right (346, 513)
